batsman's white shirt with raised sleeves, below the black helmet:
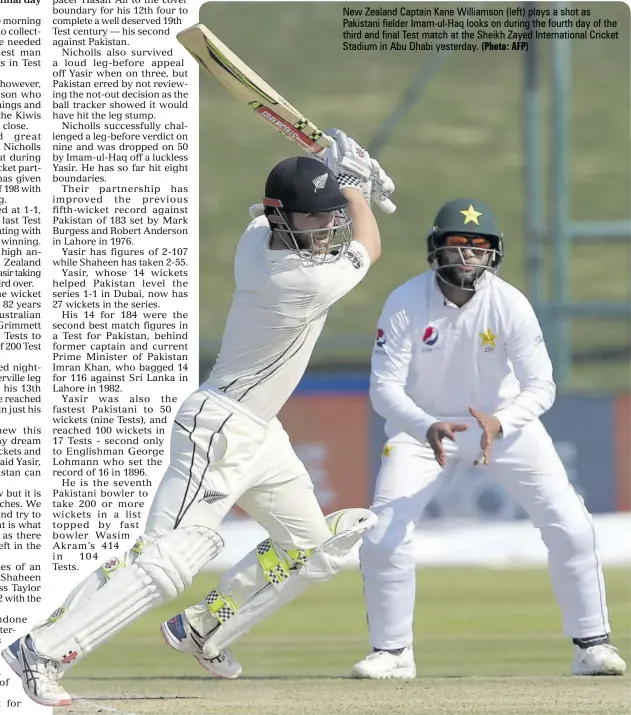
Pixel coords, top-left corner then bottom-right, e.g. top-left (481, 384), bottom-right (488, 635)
top-left (205, 216), bottom-right (370, 420)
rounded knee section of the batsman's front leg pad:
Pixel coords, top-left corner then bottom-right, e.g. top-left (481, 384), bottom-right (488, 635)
top-left (134, 526), bottom-right (223, 600)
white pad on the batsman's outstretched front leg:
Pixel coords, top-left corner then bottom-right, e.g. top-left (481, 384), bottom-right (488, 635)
top-left (32, 526), bottom-right (223, 665)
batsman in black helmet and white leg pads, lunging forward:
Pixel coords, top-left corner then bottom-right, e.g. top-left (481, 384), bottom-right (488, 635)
top-left (2, 130), bottom-right (394, 706)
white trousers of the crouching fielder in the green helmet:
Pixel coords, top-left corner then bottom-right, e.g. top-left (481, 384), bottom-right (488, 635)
top-left (360, 420), bottom-right (610, 649)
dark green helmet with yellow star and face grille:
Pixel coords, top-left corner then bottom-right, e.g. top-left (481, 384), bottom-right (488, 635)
top-left (427, 198), bottom-right (504, 290)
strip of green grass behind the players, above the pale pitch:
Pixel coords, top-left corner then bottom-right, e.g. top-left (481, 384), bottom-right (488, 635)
top-left (67, 569), bottom-right (631, 689)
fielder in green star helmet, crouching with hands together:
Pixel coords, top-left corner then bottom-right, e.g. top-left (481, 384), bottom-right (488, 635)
top-left (352, 199), bottom-right (626, 679)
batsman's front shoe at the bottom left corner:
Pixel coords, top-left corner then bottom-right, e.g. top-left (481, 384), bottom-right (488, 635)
top-left (2, 636), bottom-right (72, 707)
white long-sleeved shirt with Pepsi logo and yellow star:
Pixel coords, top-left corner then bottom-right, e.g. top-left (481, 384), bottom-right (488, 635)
top-left (370, 271), bottom-right (556, 442)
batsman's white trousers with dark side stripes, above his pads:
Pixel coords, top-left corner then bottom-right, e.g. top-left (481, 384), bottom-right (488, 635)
top-left (145, 385), bottom-right (331, 549)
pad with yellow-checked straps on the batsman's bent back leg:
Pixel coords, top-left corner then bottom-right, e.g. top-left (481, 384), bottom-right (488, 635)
top-left (201, 509), bottom-right (377, 658)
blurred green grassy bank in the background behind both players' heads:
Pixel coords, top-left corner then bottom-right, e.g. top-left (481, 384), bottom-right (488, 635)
top-left (195, 2), bottom-right (631, 390)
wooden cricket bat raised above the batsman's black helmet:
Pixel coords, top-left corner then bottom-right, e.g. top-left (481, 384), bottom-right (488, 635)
top-left (176, 24), bottom-right (396, 213)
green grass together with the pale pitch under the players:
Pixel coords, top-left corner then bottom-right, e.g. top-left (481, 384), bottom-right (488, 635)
top-left (59, 569), bottom-right (631, 715)
